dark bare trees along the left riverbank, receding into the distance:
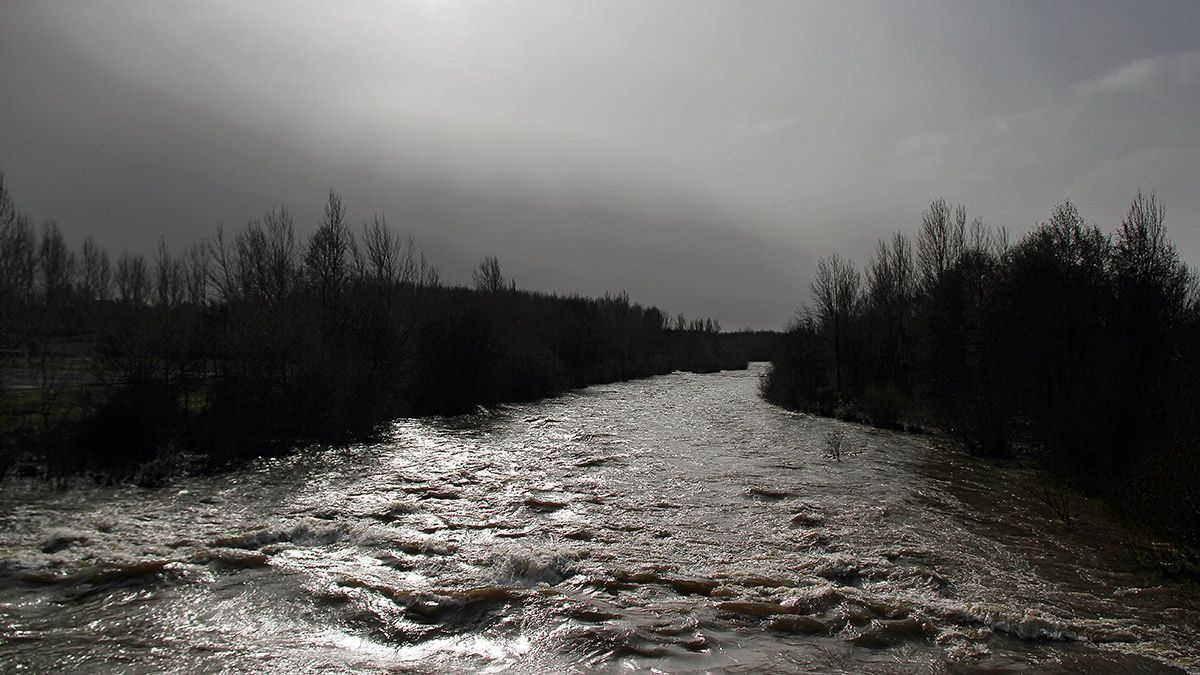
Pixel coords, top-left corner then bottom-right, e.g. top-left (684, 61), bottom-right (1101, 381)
top-left (0, 175), bottom-right (769, 478)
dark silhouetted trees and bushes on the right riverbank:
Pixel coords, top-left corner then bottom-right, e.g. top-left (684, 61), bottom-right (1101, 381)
top-left (762, 192), bottom-right (1200, 534)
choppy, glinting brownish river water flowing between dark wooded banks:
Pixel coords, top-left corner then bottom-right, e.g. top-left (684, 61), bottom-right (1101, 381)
top-left (0, 366), bottom-right (1200, 673)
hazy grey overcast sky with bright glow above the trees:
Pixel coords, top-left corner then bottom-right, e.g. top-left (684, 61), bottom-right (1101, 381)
top-left (0, 0), bottom-right (1200, 328)
